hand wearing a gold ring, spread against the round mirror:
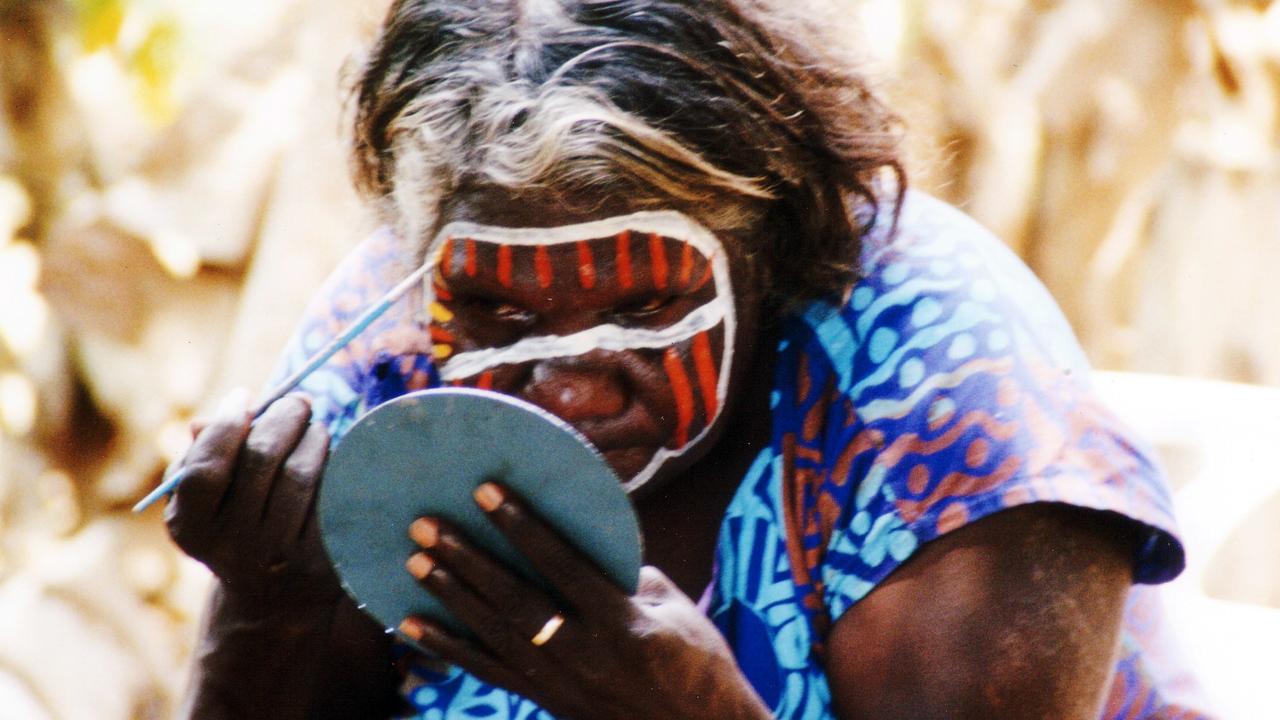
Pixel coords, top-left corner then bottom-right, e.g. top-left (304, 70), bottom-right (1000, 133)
top-left (401, 483), bottom-right (771, 720)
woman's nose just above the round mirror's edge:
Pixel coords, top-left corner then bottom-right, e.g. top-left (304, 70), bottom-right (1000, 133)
top-left (521, 352), bottom-right (628, 423)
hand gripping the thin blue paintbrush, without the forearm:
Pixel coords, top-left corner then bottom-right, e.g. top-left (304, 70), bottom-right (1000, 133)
top-left (165, 392), bottom-right (342, 612)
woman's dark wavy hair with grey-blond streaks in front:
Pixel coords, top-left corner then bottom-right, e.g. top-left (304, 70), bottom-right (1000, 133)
top-left (353, 0), bottom-right (905, 306)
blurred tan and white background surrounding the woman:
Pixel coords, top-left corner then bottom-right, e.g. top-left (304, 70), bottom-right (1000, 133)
top-left (0, 0), bottom-right (1280, 720)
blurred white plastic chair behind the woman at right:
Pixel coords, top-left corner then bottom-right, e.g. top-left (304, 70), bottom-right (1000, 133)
top-left (1094, 373), bottom-right (1280, 720)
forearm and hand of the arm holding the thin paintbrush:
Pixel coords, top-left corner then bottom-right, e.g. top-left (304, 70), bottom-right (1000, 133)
top-left (165, 396), bottom-right (396, 720)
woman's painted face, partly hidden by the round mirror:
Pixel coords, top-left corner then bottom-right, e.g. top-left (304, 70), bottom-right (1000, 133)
top-left (426, 190), bottom-right (759, 491)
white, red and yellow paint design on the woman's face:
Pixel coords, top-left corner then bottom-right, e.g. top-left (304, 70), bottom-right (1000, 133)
top-left (426, 211), bottom-right (736, 489)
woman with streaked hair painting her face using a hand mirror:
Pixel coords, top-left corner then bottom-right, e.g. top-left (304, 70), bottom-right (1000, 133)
top-left (168, 0), bottom-right (1194, 717)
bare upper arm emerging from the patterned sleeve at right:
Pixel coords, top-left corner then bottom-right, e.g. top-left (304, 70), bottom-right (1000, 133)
top-left (828, 503), bottom-right (1133, 720)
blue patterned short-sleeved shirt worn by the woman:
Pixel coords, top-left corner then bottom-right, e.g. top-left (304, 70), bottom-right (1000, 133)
top-left (267, 193), bottom-right (1204, 720)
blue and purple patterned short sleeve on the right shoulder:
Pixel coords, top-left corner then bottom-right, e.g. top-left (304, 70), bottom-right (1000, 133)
top-left (774, 196), bottom-right (1184, 619)
